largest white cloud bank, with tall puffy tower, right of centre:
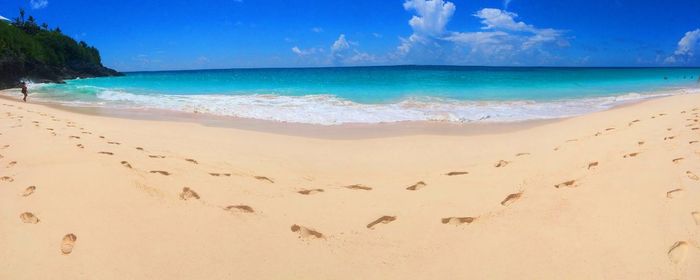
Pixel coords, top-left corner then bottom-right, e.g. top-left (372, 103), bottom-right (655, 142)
top-left (395, 0), bottom-right (569, 63)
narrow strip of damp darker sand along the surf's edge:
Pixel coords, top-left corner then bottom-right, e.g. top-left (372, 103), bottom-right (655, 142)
top-left (0, 88), bottom-right (695, 140)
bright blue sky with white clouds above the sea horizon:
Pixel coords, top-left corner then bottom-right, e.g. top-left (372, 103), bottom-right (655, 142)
top-left (0, 0), bottom-right (700, 71)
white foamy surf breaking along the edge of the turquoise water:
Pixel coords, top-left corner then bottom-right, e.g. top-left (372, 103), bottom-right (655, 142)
top-left (15, 83), bottom-right (699, 125)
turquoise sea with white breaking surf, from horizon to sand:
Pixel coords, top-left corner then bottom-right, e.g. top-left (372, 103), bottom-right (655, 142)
top-left (19, 66), bottom-right (700, 125)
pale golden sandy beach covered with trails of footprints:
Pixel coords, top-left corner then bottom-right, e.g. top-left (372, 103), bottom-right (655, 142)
top-left (0, 90), bottom-right (700, 279)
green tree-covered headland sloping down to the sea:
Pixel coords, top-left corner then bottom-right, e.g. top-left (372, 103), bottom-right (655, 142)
top-left (0, 9), bottom-right (119, 88)
